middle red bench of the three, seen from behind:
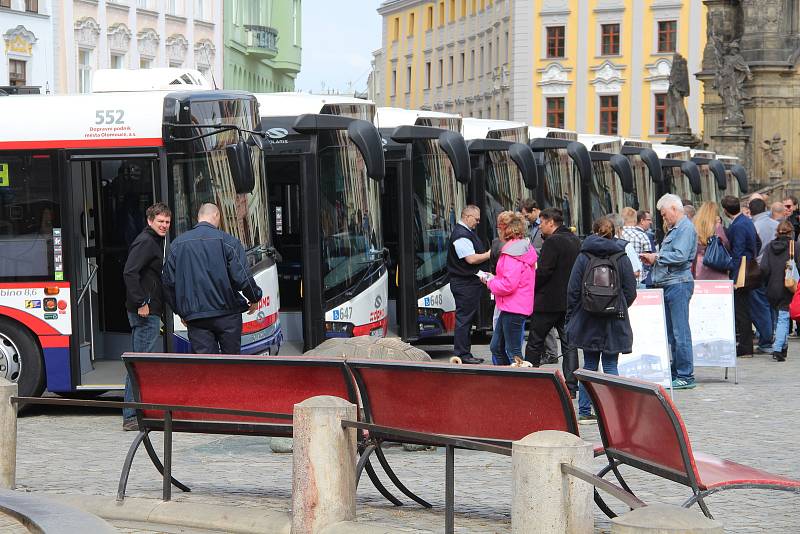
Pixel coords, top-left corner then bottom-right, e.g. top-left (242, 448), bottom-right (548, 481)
top-left (343, 360), bottom-right (578, 532)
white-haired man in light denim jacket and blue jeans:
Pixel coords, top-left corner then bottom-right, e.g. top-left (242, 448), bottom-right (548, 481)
top-left (640, 194), bottom-right (697, 389)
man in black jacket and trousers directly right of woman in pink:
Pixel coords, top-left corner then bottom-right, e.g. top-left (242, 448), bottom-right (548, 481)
top-left (525, 208), bottom-right (581, 397)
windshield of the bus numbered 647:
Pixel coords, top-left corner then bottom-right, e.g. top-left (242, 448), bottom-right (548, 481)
top-left (318, 131), bottom-right (383, 300)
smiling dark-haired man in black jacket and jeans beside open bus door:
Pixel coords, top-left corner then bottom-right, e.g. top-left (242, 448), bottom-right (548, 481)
top-left (122, 202), bottom-right (172, 428)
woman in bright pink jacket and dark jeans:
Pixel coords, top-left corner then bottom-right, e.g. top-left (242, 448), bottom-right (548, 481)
top-left (486, 213), bottom-right (536, 365)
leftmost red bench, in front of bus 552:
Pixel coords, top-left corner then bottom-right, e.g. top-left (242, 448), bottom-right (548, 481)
top-left (117, 354), bottom-right (354, 500)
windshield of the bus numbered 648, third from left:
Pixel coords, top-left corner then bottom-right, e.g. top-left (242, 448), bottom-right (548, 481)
top-left (412, 139), bottom-right (467, 297)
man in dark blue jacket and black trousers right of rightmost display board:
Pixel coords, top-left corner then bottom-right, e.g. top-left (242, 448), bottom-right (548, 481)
top-left (720, 195), bottom-right (758, 358)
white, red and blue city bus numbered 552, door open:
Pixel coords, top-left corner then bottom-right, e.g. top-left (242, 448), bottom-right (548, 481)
top-left (0, 70), bottom-right (277, 396)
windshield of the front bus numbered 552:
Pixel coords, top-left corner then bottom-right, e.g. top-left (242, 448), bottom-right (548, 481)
top-left (170, 100), bottom-right (270, 266)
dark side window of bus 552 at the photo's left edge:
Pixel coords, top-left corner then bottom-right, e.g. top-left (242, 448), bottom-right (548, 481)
top-left (0, 153), bottom-right (63, 282)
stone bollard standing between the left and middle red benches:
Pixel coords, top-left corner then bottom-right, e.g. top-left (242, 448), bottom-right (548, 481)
top-left (292, 396), bottom-right (357, 534)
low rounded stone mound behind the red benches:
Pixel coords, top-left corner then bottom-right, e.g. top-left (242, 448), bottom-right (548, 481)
top-left (304, 336), bottom-right (431, 362)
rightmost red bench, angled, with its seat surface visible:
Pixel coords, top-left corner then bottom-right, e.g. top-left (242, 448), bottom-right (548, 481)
top-left (575, 370), bottom-right (800, 518)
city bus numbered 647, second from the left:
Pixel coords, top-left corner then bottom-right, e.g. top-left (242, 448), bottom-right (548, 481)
top-left (256, 93), bottom-right (388, 350)
